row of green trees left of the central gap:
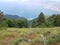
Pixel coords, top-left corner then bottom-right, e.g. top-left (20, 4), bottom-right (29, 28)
top-left (0, 11), bottom-right (28, 28)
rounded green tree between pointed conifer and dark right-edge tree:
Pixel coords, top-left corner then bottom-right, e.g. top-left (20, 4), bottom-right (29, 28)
top-left (46, 14), bottom-right (56, 27)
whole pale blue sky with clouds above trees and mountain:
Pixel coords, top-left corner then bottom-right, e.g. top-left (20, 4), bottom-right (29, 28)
top-left (0, 0), bottom-right (60, 19)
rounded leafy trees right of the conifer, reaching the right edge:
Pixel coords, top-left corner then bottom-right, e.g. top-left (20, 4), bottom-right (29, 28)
top-left (47, 14), bottom-right (60, 27)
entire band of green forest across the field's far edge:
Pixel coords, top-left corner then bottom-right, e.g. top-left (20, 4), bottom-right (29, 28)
top-left (0, 11), bottom-right (60, 28)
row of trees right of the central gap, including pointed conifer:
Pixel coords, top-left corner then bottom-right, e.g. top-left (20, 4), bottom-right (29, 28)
top-left (32, 12), bottom-right (60, 27)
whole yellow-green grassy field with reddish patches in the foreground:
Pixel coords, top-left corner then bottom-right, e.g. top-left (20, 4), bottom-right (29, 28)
top-left (0, 27), bottom-right (60, 45)
